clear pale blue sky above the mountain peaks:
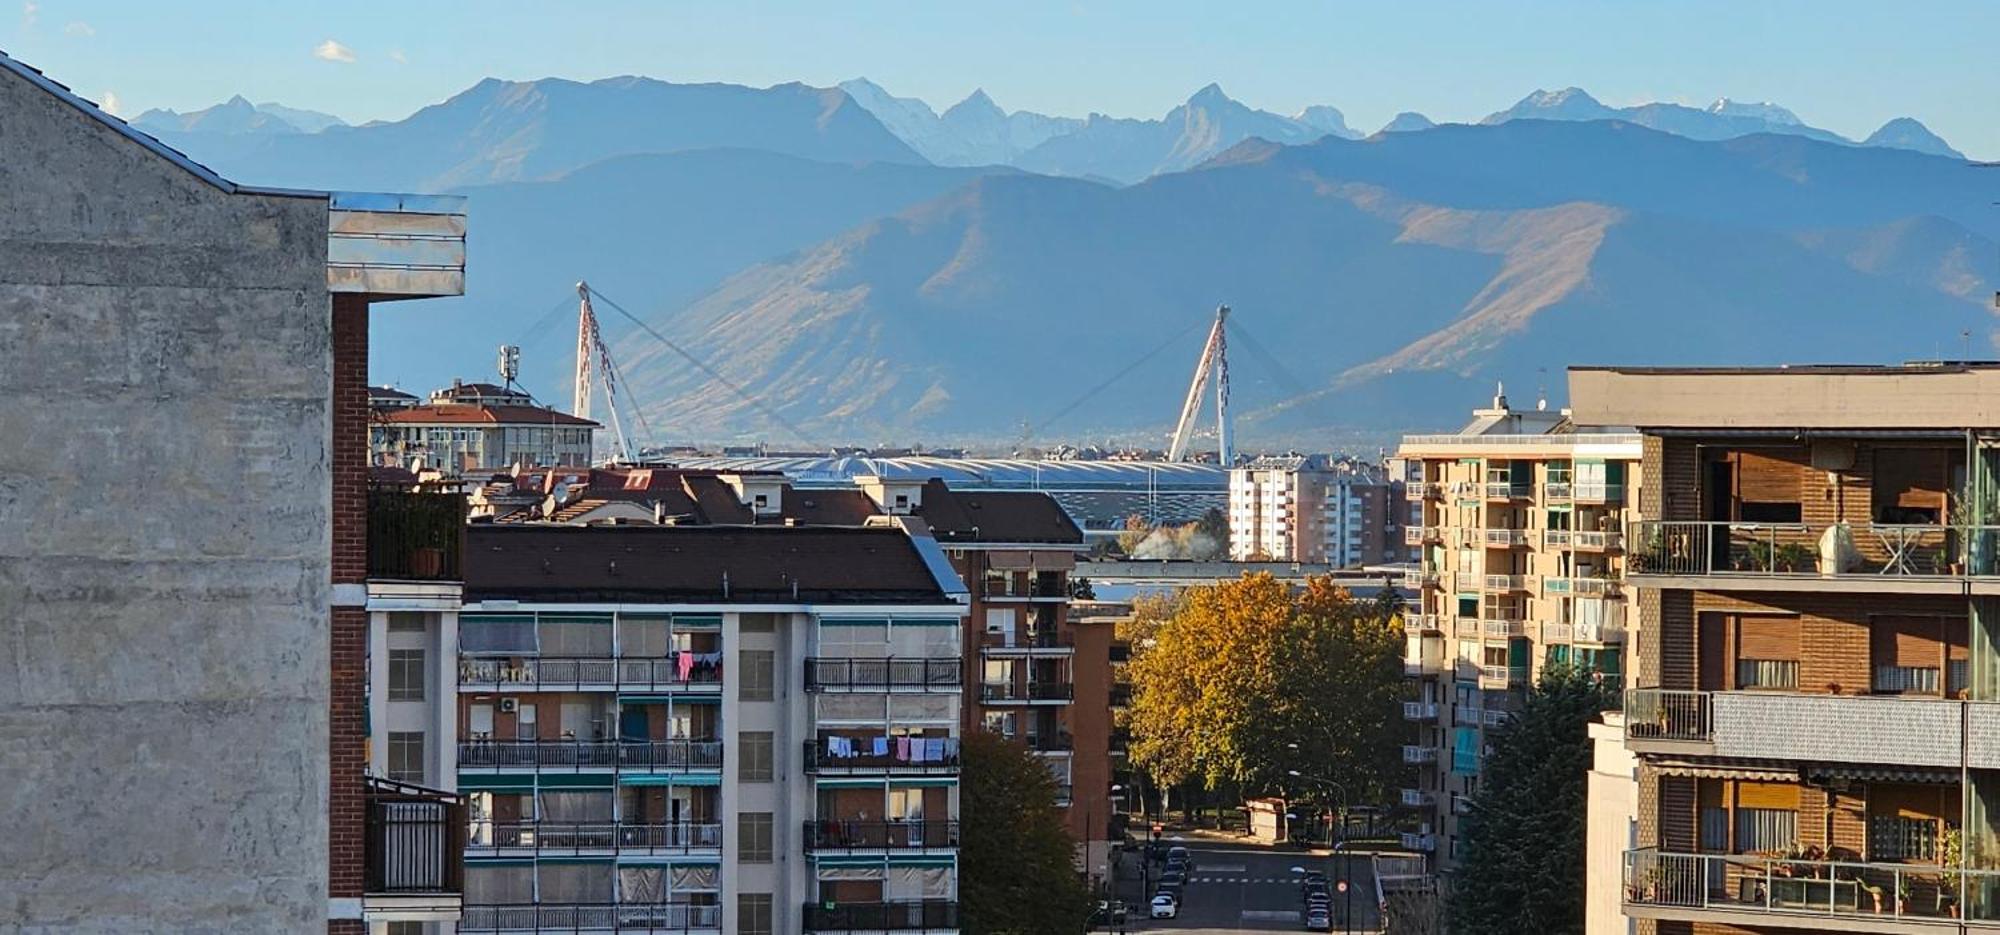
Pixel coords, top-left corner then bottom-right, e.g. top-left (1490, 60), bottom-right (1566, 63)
top-left (0, 0), bottom-right (2000, 160)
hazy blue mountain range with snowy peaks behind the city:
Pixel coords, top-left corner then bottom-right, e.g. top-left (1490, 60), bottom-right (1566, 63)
top-left (133, 78), bottom-right (2000, 448)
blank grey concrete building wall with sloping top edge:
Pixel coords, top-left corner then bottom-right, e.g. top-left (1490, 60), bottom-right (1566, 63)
top-left (0, 62), bottom-right (332, 933)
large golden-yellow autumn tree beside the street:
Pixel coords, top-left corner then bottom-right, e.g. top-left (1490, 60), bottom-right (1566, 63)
top-left (1130, 573), bottom-right (1402, 805)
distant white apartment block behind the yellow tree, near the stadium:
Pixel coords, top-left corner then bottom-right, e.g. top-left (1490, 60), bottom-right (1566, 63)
top-left (1228, 456), bottom-right (1406, 567)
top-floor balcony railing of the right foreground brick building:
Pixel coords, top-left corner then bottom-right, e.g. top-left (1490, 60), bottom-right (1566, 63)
top-left (1626, 519), bottom-right (2000, 579)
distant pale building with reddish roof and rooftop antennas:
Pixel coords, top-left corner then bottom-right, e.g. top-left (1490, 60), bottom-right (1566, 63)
top-left (368, 380), bottom-right (602, 473)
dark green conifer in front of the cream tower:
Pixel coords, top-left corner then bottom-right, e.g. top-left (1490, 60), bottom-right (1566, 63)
top-left (1452, 665), bottom-right (1614, 935)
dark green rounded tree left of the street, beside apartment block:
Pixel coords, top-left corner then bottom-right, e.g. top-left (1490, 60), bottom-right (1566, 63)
top-left (958, 731), bottom-right (1090, 935)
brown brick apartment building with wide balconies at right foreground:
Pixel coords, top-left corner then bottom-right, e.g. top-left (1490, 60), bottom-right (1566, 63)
top-left (1570, 364), bottom-right (2000, 935)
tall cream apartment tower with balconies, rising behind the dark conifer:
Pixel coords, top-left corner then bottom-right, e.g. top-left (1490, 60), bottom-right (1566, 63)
top-left (1398, 394), bottom-right (1642, 869)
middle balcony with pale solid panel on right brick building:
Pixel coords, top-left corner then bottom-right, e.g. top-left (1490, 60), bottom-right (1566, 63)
top-left (1624, 689), bottom-right (1968, 769)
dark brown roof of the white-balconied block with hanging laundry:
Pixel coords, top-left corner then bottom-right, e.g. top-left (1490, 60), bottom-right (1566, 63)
top-left (464, 523), bottom-right (948, 603)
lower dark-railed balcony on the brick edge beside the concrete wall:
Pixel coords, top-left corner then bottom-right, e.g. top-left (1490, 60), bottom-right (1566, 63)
top-left (362, 779), bottom-right (466, 921)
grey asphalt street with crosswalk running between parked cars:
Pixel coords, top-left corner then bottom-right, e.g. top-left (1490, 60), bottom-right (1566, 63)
top-left (1122, 841), bottom-right (1376, 935)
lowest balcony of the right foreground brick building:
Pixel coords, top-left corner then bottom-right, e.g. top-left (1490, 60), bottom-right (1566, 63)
top-left (1622, 847), bottom-right (2000, 933)
